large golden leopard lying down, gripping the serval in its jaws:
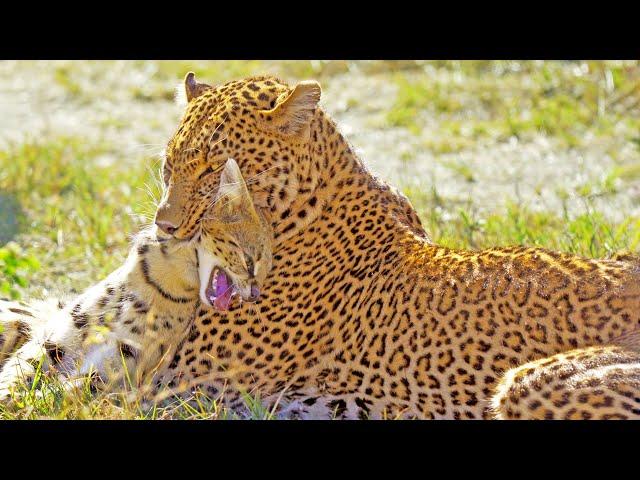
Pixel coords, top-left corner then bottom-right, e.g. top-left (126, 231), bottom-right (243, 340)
top-left (150, 72), bottom-right (640, 419)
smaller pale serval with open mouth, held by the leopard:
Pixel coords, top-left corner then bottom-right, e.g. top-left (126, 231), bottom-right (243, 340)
top-left (0, 159), bottom-right (271, 398)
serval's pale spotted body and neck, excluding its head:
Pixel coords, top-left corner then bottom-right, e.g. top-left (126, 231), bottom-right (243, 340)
top-left (0, 229), bottom-right (199, 397)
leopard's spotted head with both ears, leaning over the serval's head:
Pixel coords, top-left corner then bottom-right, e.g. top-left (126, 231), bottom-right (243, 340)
top-left (156, 73), bottom-right (322, 240)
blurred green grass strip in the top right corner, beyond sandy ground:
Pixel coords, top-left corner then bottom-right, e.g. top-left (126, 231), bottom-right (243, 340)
top-left (387, 62), bottom-right (640, 150)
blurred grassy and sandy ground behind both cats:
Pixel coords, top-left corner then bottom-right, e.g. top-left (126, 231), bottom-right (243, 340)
top-left (0, 61), bottom-right (640, 416)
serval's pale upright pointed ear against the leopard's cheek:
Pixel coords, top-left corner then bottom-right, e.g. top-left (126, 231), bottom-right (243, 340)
top-left (214, 158), bottom-right (256, 220)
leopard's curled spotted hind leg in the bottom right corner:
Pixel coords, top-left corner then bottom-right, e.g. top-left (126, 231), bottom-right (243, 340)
top-left (492, 338), bottom-right (640, 420)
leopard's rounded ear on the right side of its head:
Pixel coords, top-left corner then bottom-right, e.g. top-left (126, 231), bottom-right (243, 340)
top-left (260, 80), bottom-right (322, 135)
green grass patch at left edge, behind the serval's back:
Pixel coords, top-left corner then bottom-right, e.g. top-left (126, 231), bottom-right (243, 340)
top-left (0, 137), bottom-right (160, 293)
